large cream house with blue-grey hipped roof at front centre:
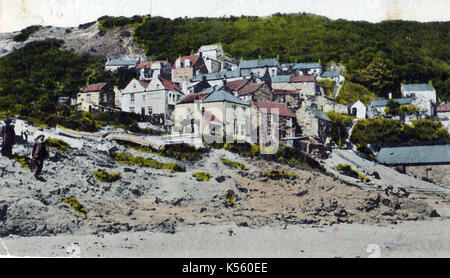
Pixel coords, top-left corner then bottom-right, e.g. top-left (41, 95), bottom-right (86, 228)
top-left (174, 86), bottom-right (250, 141)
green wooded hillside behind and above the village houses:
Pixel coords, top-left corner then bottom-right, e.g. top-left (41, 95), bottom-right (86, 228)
top-left (127, 14), bottom-right (450, 100)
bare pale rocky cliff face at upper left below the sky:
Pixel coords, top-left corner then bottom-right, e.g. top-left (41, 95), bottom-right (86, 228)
top-left (0, 22), bottom-right (145, 59)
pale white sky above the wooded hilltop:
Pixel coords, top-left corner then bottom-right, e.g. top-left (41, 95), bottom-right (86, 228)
top-left (0, 0), bottom-right (450, 32)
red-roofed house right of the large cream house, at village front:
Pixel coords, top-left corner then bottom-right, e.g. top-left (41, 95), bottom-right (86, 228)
top-left (250, 101), bottom-right (296, 147)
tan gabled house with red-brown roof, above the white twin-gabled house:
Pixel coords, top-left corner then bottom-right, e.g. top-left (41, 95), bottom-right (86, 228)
top-left (172, 53), bottom-right (208, 84)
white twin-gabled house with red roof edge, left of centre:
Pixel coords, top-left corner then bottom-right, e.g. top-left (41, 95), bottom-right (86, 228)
top-left (122, 76), bottom-right (183, 128)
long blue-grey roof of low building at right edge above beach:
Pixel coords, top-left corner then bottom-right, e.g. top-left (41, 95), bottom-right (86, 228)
top-left (377, 144), bottom-right (450, 165)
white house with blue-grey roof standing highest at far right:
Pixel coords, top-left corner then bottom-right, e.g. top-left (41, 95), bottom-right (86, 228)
top-left (401, 83), bottom-right (436, 117)
